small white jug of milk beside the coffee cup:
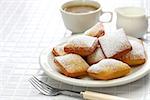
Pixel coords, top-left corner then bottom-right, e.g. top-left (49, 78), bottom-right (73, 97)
top-left (115, 7), bottom-right (149, 38)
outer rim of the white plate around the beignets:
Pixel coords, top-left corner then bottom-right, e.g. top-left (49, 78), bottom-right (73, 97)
top-left (39, 36), bottom-right (150, 87)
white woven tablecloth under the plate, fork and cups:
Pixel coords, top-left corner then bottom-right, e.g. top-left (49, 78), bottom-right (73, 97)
top-left (0, 0), bottom-right (150, 100)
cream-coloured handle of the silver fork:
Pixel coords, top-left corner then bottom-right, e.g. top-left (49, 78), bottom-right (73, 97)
top-left (81, 91), bottom-right (129, 100)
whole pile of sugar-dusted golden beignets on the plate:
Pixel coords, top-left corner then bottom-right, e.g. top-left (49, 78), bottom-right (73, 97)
top-left (52, 22), bottom-right (146, 80)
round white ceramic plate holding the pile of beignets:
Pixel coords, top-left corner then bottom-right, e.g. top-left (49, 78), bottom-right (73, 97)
top-left (40, 37), bottom-right (150, 87)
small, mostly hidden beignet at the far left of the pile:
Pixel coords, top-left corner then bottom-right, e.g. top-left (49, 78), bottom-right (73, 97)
top-left (52, 43), bottom-right (66, 56)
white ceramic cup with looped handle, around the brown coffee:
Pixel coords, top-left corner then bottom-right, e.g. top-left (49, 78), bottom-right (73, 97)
top-left (60, 0), bottom-right (112, 33)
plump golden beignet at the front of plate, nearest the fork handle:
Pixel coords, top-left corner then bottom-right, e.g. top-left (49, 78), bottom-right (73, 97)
top-left (87, 59), bottom-right (131, 80)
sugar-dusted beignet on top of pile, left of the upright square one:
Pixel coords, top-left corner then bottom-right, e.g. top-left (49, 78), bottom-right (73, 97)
top-left (64, 35), bottom-right (98, 56)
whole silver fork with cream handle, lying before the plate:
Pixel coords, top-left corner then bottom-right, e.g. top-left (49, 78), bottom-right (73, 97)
top-left (29, 76), bottom-right (129, 100)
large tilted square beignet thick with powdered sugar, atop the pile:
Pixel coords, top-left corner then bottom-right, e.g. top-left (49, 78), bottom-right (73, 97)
top-left (99, 29), bottom-right (132, 59)
